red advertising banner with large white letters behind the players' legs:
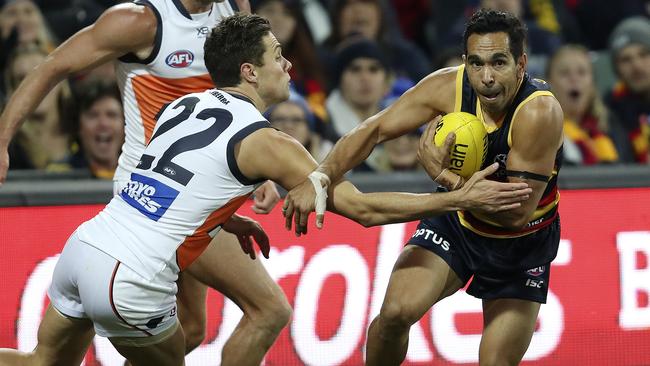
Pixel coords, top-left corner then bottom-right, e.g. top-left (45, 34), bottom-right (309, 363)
top-left (0, 188), bottom-right (650, 366)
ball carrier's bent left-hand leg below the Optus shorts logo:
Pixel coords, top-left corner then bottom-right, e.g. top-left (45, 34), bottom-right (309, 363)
top-left (366, 245), bottom-right (463, 365)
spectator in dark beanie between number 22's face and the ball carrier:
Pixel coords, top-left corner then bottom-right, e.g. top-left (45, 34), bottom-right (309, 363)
top-left (325, 37), bottom-right (390, 171)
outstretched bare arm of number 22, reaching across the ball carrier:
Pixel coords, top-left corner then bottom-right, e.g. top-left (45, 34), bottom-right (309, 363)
top-left (236, 129), bottom-right (530, 235)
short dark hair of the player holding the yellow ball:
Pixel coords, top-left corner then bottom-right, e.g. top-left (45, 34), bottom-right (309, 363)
top-left (463, 9), bottom-right (527, 60)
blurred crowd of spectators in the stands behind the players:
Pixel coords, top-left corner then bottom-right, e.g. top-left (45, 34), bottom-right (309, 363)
top-left (0, 0), bottom-right (650, 179)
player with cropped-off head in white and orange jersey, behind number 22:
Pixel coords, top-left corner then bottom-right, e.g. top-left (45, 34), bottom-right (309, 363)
top-left (0, 0), bottom-right (291, 363)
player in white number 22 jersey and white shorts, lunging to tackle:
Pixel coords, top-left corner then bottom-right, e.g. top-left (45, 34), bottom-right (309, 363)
top-left (0, 14), bottom-right (530, 365)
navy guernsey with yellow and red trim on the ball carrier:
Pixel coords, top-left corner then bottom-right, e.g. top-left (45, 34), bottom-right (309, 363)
top-left (454, 65), bottom-right (562, 238)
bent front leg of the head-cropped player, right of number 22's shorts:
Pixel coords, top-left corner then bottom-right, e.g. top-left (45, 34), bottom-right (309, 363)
top-left (187, 231), bottom-right (291, 366)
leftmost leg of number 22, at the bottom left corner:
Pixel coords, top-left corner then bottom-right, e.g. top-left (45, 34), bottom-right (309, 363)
top-left (0, 305), bottom-right (95, 366)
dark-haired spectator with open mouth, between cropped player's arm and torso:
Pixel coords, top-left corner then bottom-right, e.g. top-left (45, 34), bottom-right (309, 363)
top-left (70, 80), bottom-right (124, 180)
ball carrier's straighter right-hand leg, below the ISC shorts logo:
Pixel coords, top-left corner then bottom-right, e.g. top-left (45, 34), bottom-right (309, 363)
top-left (479, 299), bottom-right (541, 366)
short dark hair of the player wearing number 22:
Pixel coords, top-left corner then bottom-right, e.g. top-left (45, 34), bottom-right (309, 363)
top-left (203, 13), bottom-right (271, 88)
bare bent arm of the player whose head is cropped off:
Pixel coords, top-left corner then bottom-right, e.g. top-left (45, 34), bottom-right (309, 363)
top-left (0, 4), bottom-right (156, 184)
